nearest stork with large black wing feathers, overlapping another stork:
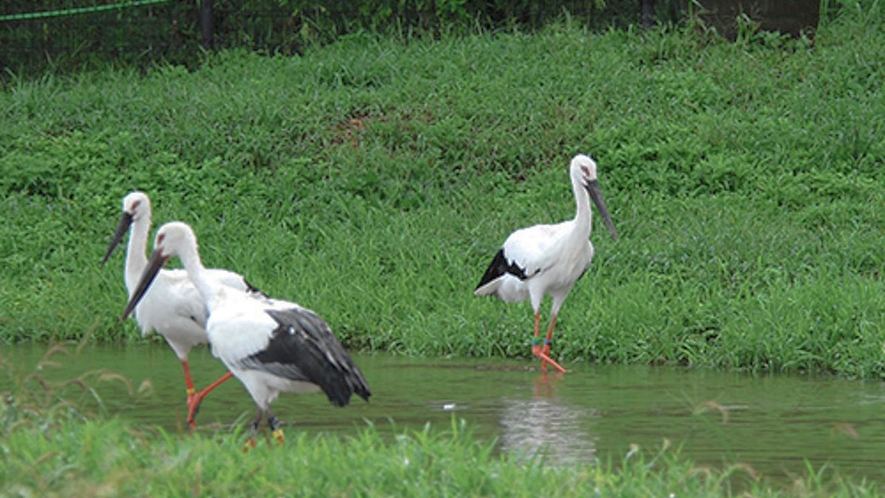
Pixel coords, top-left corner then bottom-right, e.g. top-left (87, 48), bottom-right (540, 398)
top-left (123, 222), bottom-right (371, 449)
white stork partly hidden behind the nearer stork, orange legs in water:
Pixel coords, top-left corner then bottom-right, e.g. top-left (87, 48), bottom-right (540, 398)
top-left (101, 192), bottom-right (259, 427)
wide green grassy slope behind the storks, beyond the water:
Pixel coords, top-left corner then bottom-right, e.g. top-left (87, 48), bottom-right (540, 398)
top-left (0, 4), bottom-right (885, 377)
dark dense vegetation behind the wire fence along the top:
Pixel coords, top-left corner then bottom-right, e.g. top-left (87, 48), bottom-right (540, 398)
top-left (0, 0), bottom-right (664, 75)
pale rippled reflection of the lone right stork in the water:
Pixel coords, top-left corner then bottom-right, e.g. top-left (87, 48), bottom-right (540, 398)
top-left (500, 374), bottom-right (598, 464)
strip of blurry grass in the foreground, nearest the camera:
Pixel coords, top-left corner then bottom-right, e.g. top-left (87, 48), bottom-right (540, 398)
top-left (0, 420), bottom-right (877, 497)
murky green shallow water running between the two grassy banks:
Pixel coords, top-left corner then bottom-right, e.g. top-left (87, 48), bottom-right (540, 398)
top-left (0, 344), bottom-right (885, 483)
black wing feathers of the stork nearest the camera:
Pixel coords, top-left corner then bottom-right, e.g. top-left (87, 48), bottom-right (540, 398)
top-left (243, 308), bottom-right (372, 406)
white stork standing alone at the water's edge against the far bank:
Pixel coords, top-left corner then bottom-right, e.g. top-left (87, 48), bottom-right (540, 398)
top-left (473, 154), bottom-right (618, 372)
